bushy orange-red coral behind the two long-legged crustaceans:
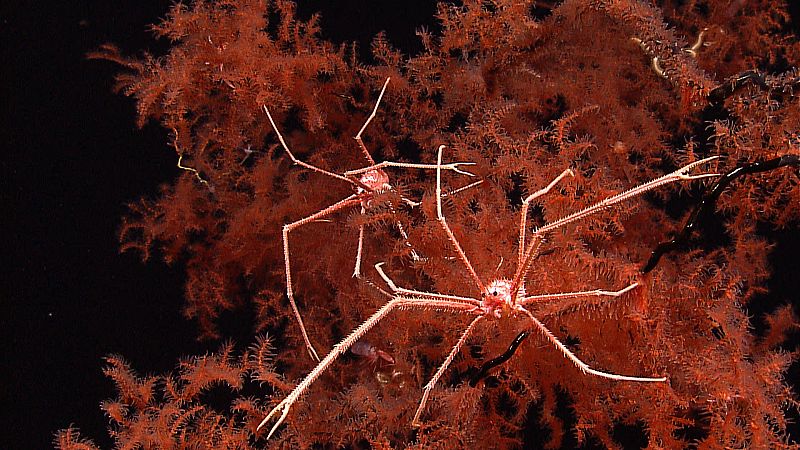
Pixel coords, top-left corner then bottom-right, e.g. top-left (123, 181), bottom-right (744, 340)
top-left (69, 0), bottom-right (800, 448)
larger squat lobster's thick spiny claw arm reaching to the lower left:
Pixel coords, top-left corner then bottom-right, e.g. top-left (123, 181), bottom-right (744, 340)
top-left (257, 297), bottom-right (476, 439)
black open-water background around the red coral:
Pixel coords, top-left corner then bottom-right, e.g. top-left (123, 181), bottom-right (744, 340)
top-left (0, 0), bottom-right (800, 449)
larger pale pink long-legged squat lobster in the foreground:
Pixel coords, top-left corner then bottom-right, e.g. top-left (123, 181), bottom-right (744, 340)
top-left (258, 146), bottom-right (718, 439)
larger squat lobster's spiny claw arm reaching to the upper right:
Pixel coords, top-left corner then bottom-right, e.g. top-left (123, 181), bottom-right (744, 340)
top-left (513, 156), bottom-right (719, 286)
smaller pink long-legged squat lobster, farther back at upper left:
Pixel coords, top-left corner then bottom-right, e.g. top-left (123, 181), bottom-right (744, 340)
top-left (264, 78), bottom-right (474, 362)
